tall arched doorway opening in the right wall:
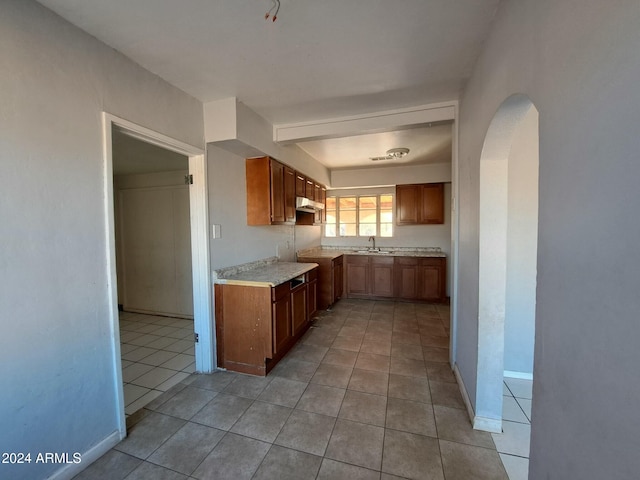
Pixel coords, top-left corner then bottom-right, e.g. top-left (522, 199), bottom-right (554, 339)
top-left (474, 94), bottom-right (539, 432)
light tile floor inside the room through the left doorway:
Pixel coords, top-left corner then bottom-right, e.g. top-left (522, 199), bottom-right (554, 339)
top-left (120, 312), bottom-right (195, 416)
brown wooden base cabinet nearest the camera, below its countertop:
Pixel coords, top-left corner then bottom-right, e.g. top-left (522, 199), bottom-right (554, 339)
top-left (215, 268), bottom-right (317, 376)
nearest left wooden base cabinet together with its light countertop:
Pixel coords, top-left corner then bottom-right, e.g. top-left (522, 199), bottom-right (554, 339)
top-left (214, 257), bottom-right (318, 376)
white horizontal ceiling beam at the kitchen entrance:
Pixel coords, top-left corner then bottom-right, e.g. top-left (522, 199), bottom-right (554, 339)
top-left (273, 101), bottom-right (458, 144)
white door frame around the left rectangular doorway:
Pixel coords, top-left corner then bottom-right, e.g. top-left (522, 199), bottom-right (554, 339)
top-left (102, 112), bottom-right (216, 432)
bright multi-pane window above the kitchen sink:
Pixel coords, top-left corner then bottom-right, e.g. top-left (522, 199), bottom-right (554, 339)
top-left (324, 194), bottom-right (393, 237)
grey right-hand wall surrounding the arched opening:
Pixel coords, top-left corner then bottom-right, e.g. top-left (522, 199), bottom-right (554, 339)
top-left (456, 0), bottom-right (640, 480)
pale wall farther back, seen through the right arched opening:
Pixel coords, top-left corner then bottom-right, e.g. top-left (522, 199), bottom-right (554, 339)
top-left (504, 108), bottom-right (539, 374)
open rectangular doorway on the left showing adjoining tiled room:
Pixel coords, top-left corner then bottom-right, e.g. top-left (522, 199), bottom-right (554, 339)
top-left (112, 128), bottom-right (195, 415)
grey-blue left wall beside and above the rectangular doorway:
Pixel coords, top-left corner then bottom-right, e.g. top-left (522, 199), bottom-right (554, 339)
top-left (0, 0), bottom-right (203, 479)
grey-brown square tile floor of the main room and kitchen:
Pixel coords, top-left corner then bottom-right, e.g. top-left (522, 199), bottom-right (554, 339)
top-left (77, 300), bottom-right (507, 480)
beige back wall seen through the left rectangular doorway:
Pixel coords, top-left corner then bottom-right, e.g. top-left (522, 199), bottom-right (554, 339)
top-left (114, 172), bottom-right (193, 318)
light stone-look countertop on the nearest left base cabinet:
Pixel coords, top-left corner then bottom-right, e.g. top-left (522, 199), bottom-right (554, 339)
top-left (213, 257), bottom-right (318, 287)
